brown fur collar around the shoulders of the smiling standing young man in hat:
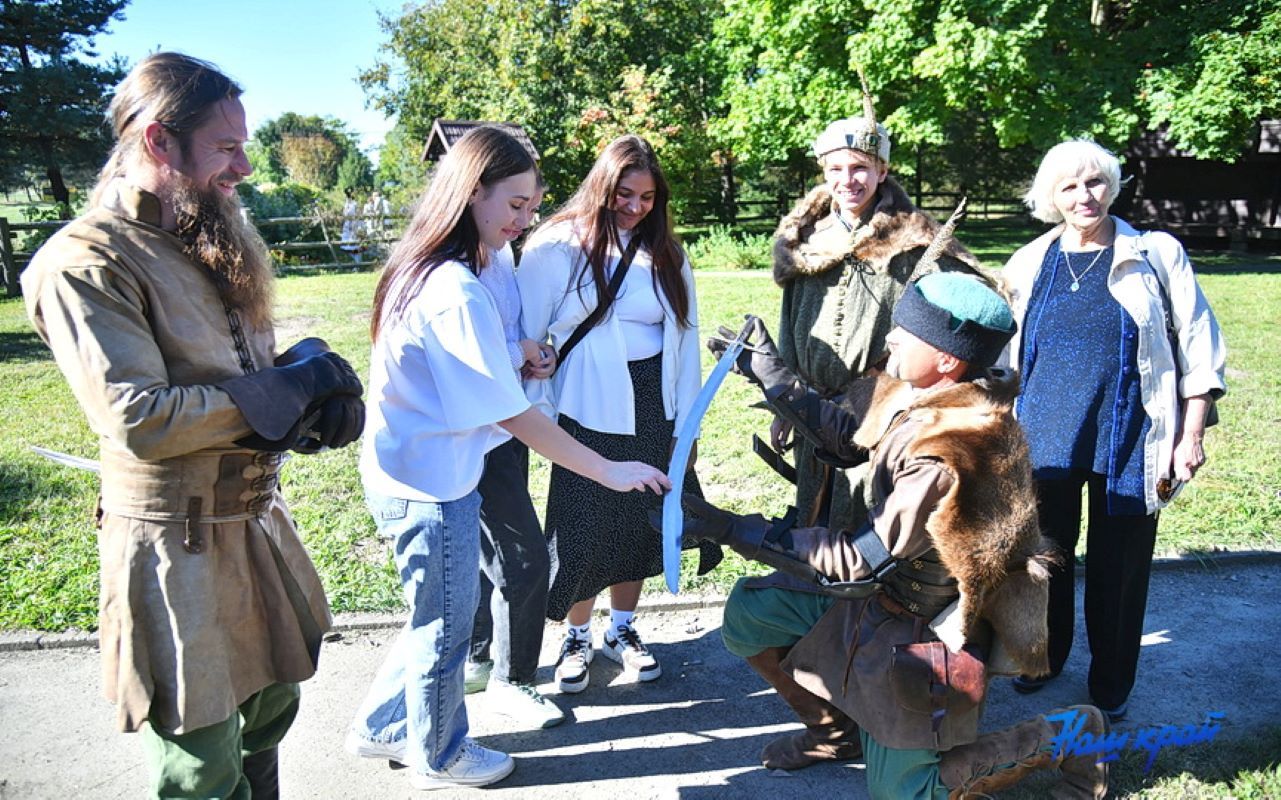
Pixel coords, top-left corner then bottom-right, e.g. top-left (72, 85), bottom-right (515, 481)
top-left (774, 177), bottom-right (981, 285)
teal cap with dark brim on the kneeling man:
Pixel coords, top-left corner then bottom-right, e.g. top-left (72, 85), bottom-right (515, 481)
top-left (894, 273), bottom-right (1017, 367)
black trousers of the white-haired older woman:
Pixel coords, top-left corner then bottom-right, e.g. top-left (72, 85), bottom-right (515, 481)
top-left (1036, 470), bottom-right (1157, 709)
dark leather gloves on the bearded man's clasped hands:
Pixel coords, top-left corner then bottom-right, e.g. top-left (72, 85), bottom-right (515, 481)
top-left (218, 338), bottom-right (364, 451)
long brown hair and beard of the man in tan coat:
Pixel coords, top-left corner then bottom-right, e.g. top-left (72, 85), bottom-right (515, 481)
top-left (90, 52), bottom-right (273, 329)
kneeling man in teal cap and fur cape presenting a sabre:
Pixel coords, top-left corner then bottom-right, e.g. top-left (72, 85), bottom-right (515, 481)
top-left (684, 273), bottom-right (1107, 797)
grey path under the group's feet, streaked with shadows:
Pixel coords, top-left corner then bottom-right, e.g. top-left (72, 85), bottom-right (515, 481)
top-left (0, 558), bottom-right (1281, 800)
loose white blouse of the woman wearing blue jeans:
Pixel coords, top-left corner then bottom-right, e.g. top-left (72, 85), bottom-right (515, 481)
top-left (360, 261), bottom-right (529, 503)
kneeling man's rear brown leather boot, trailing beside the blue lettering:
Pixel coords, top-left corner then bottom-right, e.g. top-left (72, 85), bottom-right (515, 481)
top-left (939, 705), bottom-right (1108, 800)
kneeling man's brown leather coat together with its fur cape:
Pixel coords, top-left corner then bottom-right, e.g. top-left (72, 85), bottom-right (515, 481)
top-left (758, 370), bottom-right (1050, 750)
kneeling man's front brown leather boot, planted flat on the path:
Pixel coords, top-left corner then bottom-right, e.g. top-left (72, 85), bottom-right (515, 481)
top-left (747, 648), bottom-right (863, 769)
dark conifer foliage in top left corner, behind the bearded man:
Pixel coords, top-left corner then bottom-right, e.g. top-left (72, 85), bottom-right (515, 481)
top-left (0, 0), bottom-right (128, 210)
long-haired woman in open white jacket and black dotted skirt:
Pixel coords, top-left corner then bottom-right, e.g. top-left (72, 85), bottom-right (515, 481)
top-left (516, 136), bottom-right (720, 692)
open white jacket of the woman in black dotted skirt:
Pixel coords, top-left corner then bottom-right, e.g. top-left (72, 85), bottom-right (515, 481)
top-left (516, 223), bottom-right (702, 435)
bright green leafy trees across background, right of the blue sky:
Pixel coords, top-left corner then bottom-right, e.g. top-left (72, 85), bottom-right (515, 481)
top-left (361, 0), bottom-right (1281, 212)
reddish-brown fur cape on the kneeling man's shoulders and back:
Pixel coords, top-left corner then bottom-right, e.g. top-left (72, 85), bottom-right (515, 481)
top-left (854, 369), bottom-right (1056, 675)
